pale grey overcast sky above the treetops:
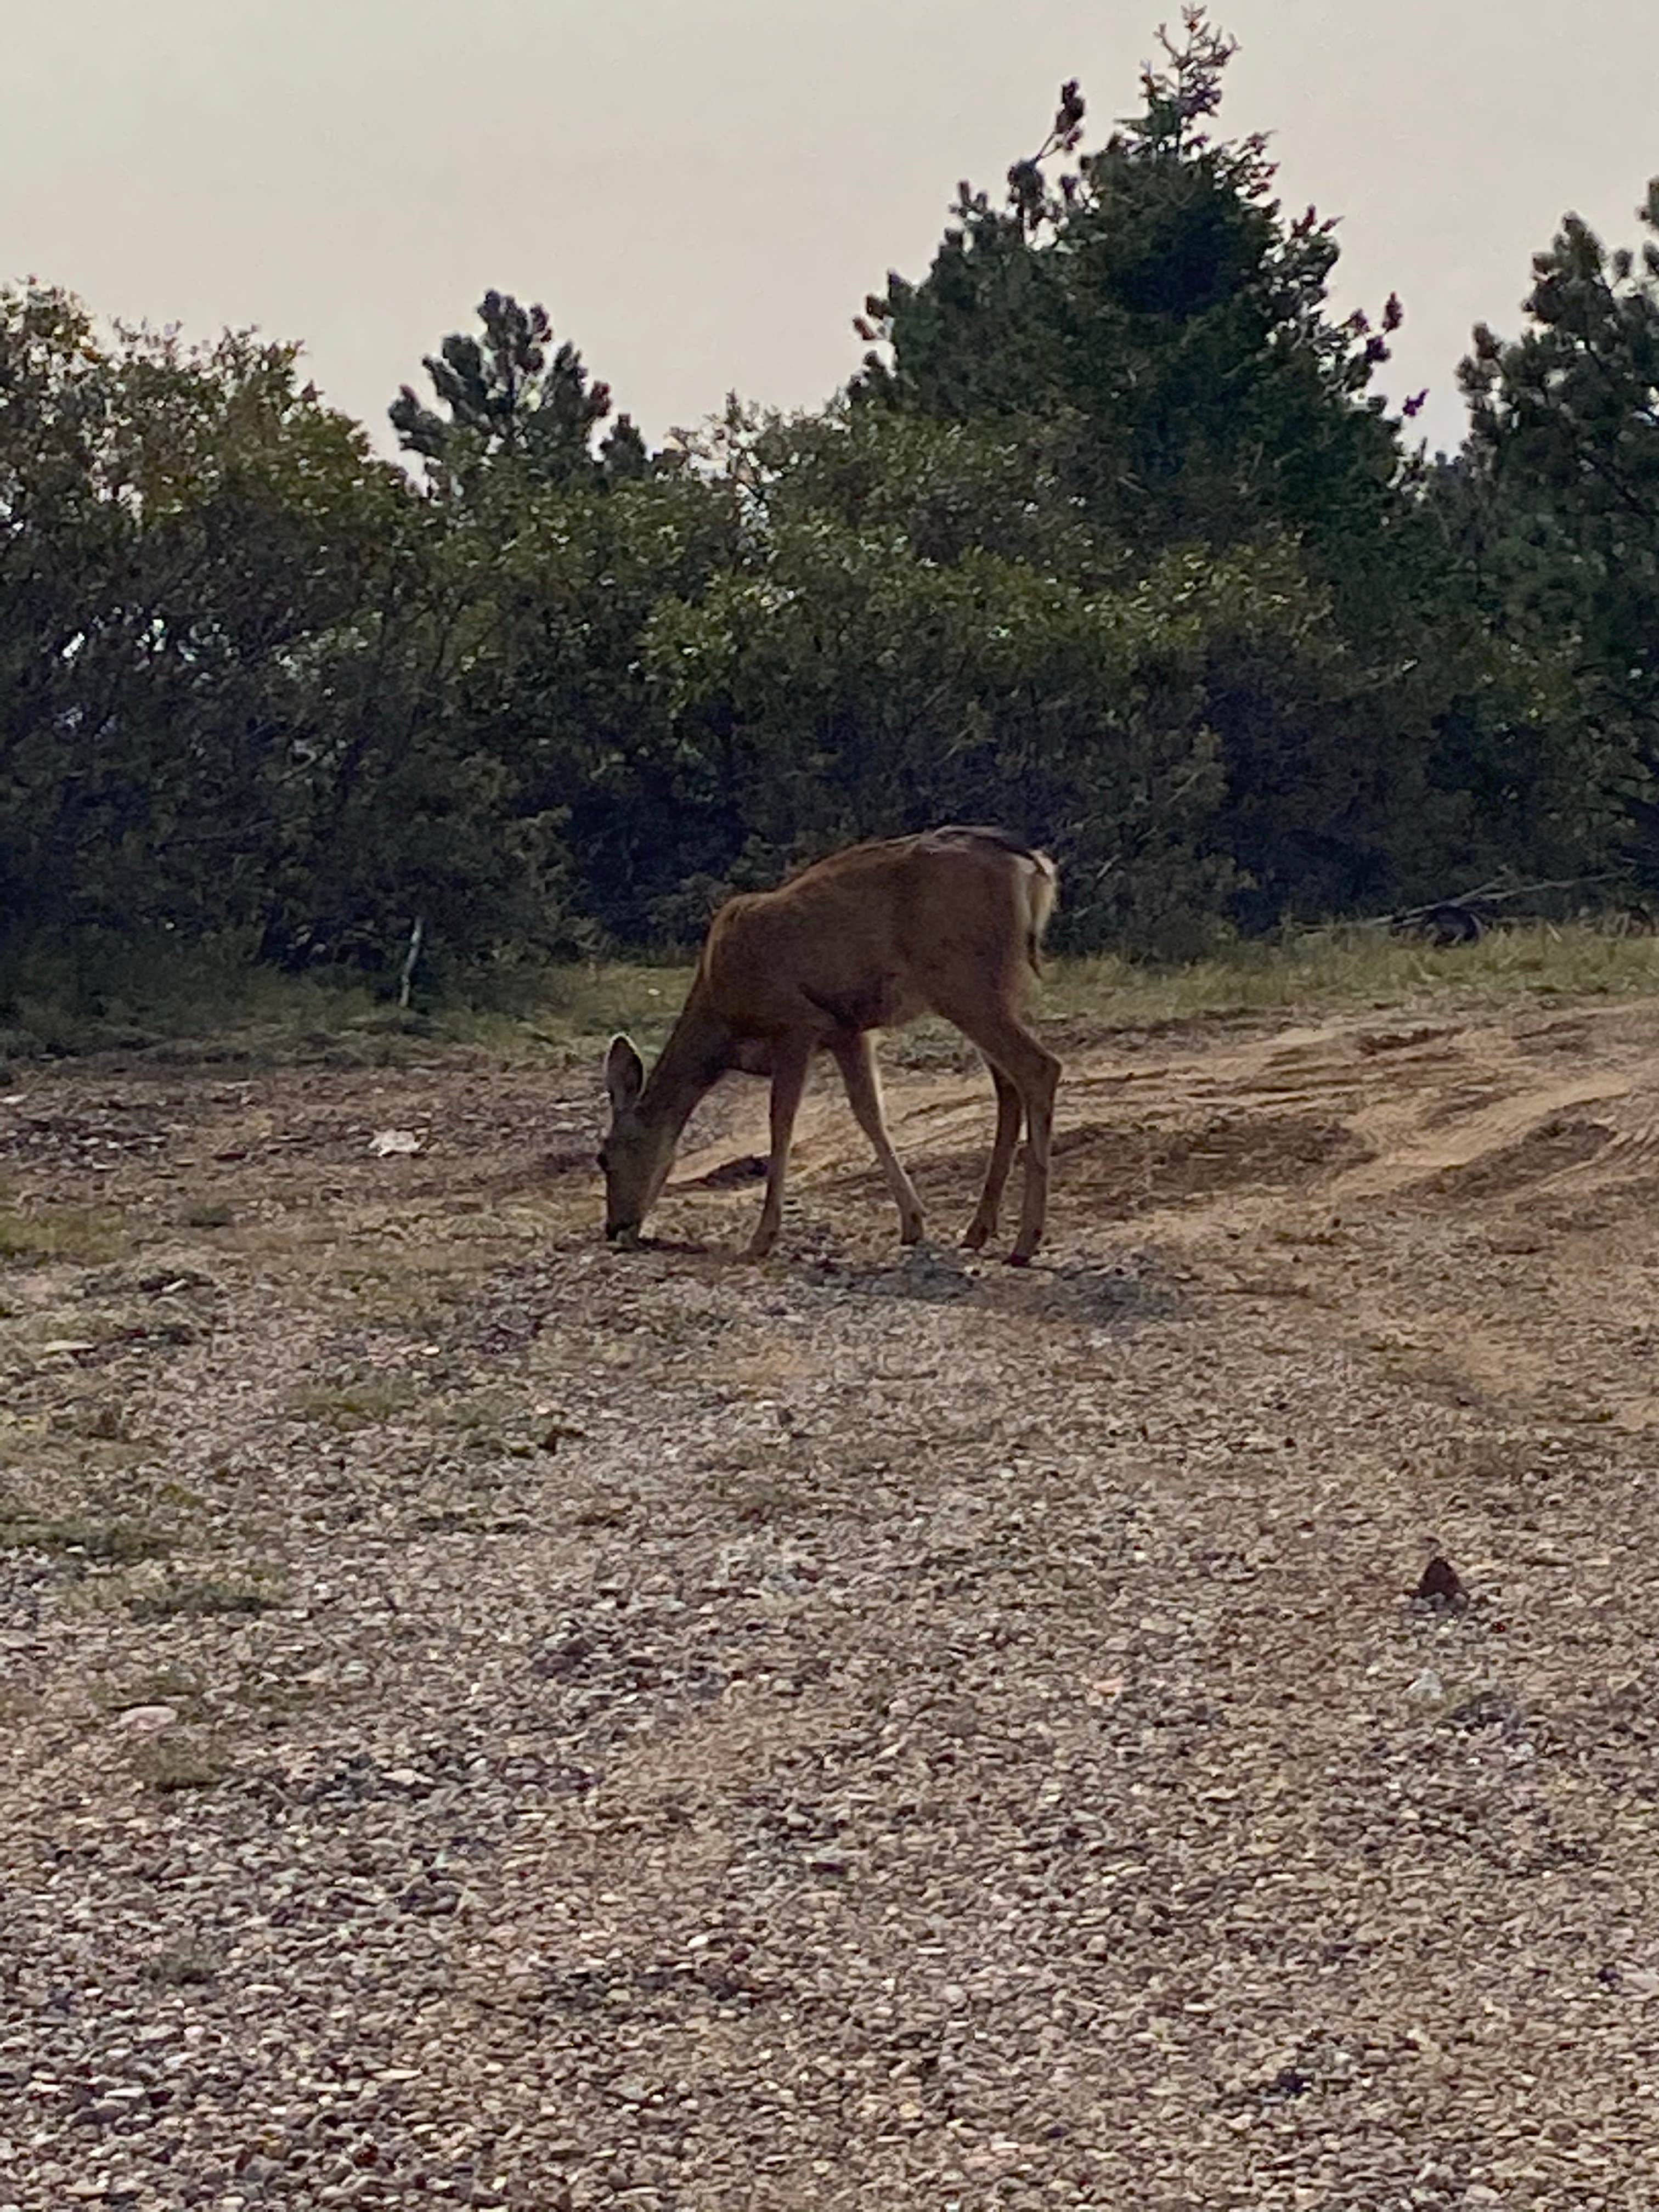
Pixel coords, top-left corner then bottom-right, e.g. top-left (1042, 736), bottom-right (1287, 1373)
top-left (0, 0), bottom-right (1659, 460)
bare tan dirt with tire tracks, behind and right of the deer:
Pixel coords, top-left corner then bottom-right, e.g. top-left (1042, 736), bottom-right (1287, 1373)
top-left (670, 1007), bottom-right (1659, 1427)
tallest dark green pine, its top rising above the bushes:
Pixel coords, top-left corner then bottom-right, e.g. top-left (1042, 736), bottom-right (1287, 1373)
top-left (856, 7), bottom-right (1411, 608)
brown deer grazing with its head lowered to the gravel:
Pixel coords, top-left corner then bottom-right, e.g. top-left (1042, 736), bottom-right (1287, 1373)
top-left (600, 823), bottom-right (1062, 1267)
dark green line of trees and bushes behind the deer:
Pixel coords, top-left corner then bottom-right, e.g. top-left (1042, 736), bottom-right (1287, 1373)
top-left (0, 9), bottom-right (1659, 995)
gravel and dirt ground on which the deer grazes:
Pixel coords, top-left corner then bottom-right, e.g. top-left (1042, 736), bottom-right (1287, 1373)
top-left (0, 1007), bottom-right (1659, 2212)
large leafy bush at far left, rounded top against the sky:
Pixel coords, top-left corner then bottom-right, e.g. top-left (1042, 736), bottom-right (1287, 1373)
top-left (0, 287), bottom-right (571, 978)
